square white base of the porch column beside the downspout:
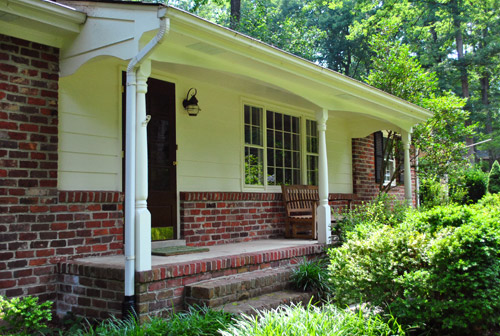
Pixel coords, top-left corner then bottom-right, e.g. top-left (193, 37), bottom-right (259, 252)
top-left (135, 208), bottom-right (151, 272)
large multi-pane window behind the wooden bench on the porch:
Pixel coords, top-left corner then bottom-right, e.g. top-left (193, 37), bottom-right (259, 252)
top-left (244, 105), bottom-right (318, 186)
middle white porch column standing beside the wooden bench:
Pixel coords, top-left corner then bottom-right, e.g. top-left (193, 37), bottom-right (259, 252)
top-left (316, 109), bottom-right (332, 244)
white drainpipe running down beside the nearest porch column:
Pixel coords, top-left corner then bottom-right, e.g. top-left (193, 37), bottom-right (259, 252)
top-left (122, 8), bottom-right (170, 319)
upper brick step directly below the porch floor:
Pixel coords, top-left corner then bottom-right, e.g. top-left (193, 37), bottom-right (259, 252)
top-left (185, 267), bottom-right (292, 307)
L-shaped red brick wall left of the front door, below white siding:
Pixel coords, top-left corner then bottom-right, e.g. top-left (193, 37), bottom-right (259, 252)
top-left (0, 34), bottom-right (123, 300)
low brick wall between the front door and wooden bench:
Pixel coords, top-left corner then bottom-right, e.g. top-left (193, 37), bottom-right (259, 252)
top-left (180, 192), bottom-right (285, 246)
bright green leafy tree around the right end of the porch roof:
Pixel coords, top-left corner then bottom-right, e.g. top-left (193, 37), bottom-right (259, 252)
top-left (366, 23), bottom-right (473, 192)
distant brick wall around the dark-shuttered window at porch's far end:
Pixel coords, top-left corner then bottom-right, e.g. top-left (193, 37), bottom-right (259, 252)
top-left (352, 134), bottom-right (416, 204)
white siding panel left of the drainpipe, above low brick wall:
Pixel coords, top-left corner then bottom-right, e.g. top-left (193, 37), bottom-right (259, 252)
top-left (59, 59), bottom-right (122, 190)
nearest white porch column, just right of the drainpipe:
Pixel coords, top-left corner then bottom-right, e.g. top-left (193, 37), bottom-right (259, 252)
top-left (135, 60), bottom-right (151, 272)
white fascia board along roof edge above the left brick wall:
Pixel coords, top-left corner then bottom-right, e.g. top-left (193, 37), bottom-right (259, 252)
top-left (0, 0), bottom-right (87, 33)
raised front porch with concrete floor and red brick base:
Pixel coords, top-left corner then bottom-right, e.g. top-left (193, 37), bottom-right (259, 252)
top-left (57, 239), bottom-right (324, 320)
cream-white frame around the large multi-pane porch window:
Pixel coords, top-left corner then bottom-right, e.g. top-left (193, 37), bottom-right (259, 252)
top-left (240, 99), bottom-right (316, 192)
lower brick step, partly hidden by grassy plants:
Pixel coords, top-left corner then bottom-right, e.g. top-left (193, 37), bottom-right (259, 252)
top-left (214, 290), bottom-right (313, 315)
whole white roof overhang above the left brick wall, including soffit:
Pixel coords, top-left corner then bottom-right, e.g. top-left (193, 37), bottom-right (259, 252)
top-left (0, 0), bottom-right (86, 48)
